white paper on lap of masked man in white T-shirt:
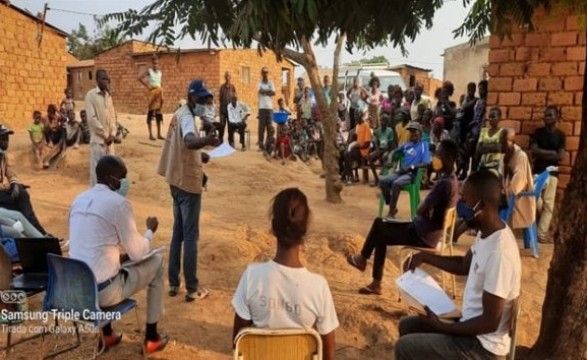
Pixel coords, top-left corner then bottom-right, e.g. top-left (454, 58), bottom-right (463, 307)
top-left (395, 268), bottom-right (457, 316)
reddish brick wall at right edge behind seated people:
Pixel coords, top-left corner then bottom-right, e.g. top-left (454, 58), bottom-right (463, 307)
top-left (487, 7), bottom-right (587, 189)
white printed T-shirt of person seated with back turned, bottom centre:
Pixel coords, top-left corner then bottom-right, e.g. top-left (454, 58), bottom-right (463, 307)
top-left (232, 261), bottom-right (339, 335)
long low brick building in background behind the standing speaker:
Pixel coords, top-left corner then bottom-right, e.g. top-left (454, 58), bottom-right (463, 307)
top-left (89, 40), bottom-right (294, 114)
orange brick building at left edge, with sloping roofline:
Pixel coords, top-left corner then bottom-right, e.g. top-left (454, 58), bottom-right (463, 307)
top-left (0, 1), bottom-right (73, 128)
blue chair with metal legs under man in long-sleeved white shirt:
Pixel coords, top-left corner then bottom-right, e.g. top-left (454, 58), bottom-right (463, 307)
top-left (43, 254), bottom-right (140, 359)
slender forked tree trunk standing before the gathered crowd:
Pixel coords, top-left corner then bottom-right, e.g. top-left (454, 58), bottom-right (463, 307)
top-left (301, 35), bottom-right (344, 203)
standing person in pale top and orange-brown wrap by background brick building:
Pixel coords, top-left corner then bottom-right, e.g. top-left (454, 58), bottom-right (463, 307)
top-left (139, 54), bottom-right (165, 140)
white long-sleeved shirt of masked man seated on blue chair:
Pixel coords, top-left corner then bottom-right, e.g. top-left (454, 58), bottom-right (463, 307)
top-left (69, 184), bottom-right (153, 284)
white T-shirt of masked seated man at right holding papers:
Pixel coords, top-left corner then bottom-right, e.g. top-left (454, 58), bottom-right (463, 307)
top-left (461, 226), bottom-right (522, 356)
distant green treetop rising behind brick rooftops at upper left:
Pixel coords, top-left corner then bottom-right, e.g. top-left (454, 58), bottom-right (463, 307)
top-left (67, 20), bottom-right (126, 60)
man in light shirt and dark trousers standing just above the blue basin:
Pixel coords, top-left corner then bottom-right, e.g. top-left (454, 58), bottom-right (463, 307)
top-left (258, 66), bottom-right (275, 152)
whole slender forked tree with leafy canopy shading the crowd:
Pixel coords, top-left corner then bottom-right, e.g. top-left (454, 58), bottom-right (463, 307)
top-left (102, 0), bottom-right (443, 203)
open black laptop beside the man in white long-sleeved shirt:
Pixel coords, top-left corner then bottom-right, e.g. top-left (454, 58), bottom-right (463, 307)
top-left (12, 238), bottom-right (61, 291)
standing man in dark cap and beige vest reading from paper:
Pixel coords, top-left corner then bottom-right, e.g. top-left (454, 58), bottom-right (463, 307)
top-left (157, 79), bottom-right (218, 302)
